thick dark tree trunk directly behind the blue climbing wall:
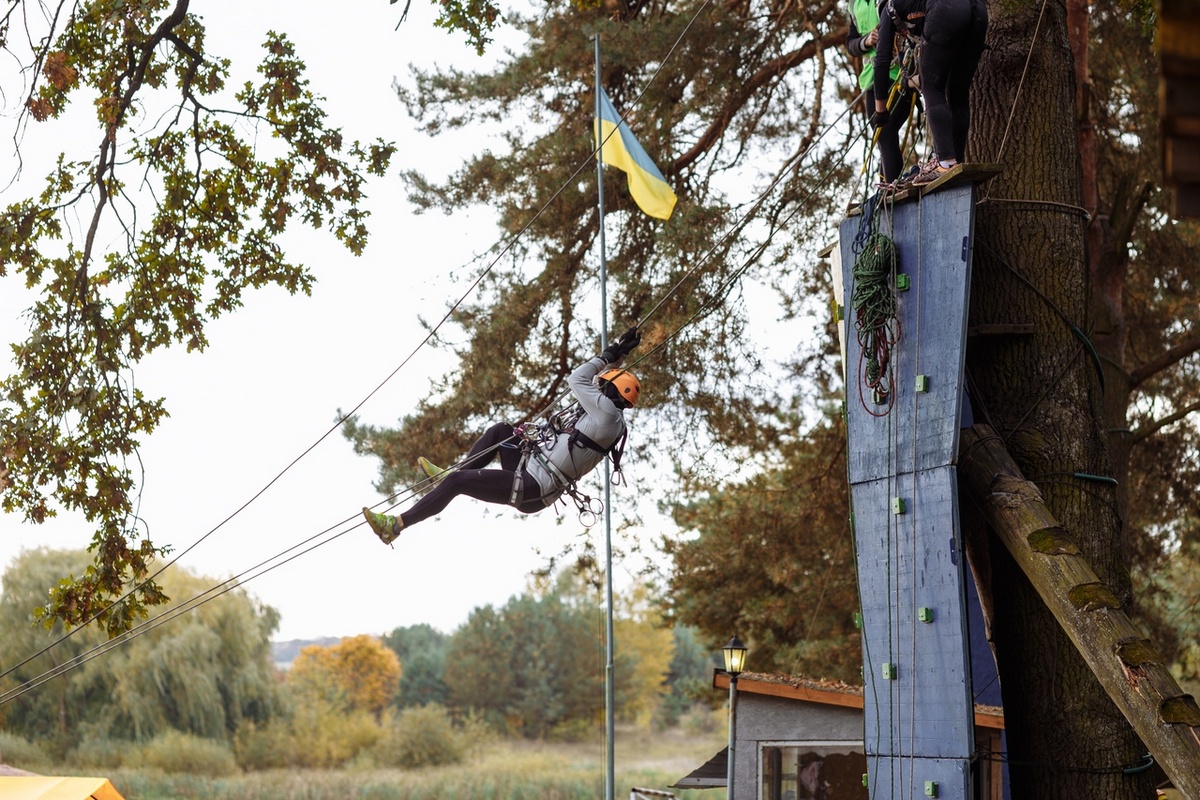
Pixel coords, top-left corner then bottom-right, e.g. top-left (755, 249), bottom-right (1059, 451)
top-left (967, 0), bottom-right (1153, 800)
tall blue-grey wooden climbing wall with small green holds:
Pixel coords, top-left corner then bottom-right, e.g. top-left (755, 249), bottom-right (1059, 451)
top-left (834, 181), bottom-right (976, 800)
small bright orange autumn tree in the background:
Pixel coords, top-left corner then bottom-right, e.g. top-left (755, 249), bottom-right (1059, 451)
top-left (288, 634), bottom-right (401, 721)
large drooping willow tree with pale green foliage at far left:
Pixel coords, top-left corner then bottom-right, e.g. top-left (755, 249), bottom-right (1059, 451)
top-left (0, 551), bottom-right (278, 748)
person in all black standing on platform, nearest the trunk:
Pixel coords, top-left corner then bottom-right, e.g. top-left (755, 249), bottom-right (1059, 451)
top-left (875, 0), bottom-right (988, 184)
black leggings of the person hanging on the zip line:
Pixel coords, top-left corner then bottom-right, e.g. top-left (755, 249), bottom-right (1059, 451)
top-left (400, 422), bottom-right (546, 528)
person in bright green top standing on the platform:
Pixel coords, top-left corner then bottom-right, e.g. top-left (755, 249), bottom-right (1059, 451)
top-left (846, 0), bottom-right (916, 186)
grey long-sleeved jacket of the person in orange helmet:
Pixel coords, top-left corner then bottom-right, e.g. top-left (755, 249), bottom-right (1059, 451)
top-left (526, 356), bottom-right (625, 505)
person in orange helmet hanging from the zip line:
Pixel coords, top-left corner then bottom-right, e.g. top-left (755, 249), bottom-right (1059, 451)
top-left (362, 326), bottom-right (642, 545)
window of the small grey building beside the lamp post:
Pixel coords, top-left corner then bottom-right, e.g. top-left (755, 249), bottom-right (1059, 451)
top-left (758, 741), bottom-right (868, 800)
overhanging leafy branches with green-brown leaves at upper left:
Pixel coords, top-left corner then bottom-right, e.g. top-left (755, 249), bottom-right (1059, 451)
top-left (0, 0), bottom-right (395, 633)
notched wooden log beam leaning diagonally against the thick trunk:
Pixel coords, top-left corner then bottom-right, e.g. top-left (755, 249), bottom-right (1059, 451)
top-left (959, 425), bottom-right (1200, 798)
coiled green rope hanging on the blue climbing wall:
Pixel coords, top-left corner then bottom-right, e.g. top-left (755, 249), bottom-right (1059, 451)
top-left (851, 233), bottom-right (896, 395)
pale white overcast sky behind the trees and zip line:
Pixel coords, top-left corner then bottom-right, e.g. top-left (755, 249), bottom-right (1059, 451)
top-left (0, 0), bottom-right (676, 640)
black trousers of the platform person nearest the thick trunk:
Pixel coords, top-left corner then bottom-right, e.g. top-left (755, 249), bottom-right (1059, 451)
top-left (920, 0), bottom-right (988, 163)
